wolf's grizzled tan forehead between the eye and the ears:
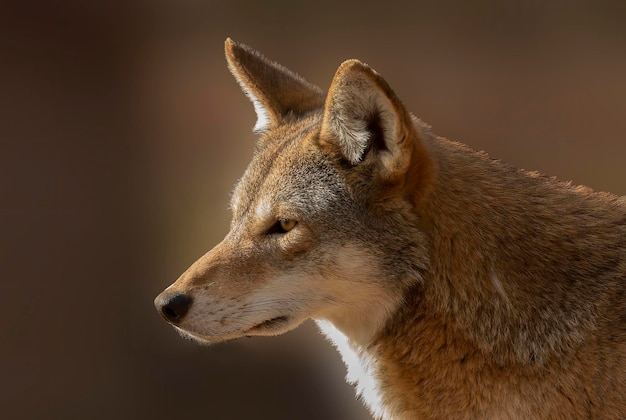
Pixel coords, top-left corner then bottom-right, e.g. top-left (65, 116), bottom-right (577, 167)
top-left (230, 115), bottom-right (350, 218)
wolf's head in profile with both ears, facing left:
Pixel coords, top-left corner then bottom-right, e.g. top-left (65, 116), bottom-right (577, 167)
top-left (155, 39), bottom-right (433, 343)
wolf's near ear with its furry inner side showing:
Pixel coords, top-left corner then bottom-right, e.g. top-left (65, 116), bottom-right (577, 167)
top-left (321, 60), bottom-right (412, 177)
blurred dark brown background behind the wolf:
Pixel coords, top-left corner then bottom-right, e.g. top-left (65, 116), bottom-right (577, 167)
top-left (0, 0), bottom-right (626, 419)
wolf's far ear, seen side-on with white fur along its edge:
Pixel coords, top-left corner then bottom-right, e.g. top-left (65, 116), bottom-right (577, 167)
top-left (225, 38), bottom-right (325, 134)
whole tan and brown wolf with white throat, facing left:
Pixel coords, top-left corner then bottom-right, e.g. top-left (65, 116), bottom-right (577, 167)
top-left (155, 40), bottom-right (626, 419)
